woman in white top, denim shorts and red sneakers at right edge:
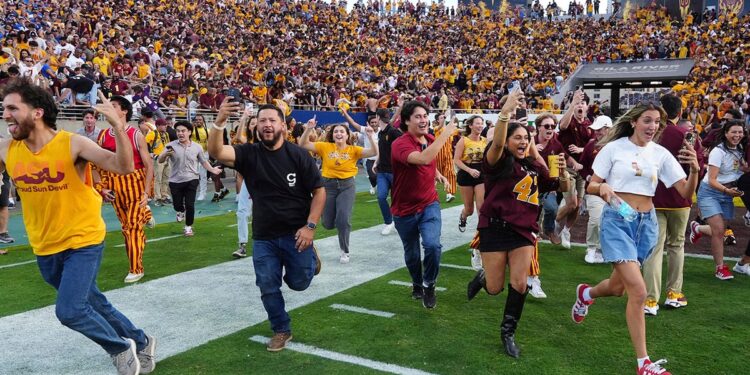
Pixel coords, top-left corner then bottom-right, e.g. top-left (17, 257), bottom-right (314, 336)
top-left (690, 120), bottom-right (748, 280)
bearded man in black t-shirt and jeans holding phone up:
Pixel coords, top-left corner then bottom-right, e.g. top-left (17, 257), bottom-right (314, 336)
top-left (207, 98), bottom-right (326, 352)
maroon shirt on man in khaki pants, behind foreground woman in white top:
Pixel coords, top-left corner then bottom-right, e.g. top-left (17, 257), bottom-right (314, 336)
top-left (653, 121), bottom-right (705, 209)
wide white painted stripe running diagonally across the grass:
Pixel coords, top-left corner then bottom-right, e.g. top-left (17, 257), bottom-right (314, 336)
top-left (0, 206), bottom-right (476, 374)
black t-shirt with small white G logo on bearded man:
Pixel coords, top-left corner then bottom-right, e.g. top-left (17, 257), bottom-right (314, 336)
top-left (234, 142), bottom-right (323, 240)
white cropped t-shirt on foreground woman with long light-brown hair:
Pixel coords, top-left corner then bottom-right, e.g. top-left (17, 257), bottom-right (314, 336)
top-left (592, 137), bottom-right (686, 197)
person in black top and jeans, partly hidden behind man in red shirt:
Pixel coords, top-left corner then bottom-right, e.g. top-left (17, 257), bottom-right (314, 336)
top-left (373, 109), bottom-right (402, 236)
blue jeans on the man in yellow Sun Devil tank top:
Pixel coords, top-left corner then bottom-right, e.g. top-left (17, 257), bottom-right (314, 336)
top-left (36, 243), bottom-right (147, 354)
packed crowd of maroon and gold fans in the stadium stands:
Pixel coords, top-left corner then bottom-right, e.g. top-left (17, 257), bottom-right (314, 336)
top-left (0, 0), bottom-right (750, 124)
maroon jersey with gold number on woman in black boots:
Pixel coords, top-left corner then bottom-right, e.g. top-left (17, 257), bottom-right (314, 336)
top-left (477, 153), bottom-right (559, 243)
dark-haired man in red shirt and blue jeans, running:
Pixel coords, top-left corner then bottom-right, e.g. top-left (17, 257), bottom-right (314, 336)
top-left (391, 100), bottom-right (456, 309)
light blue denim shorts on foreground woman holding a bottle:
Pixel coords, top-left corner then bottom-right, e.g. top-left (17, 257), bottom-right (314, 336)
top-left (599, 204), bottom-right (659, 264)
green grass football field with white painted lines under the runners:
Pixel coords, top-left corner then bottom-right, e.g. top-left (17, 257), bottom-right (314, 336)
top-left (0, 193), bottom-right (750, 374)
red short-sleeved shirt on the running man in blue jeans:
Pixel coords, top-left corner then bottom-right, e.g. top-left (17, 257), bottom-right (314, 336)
top-left (391, 133), bottom-right (438, 216)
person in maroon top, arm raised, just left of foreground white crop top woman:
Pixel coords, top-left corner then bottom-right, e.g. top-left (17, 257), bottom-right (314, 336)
top-left (555, 90), bottom-right (593, 249)
